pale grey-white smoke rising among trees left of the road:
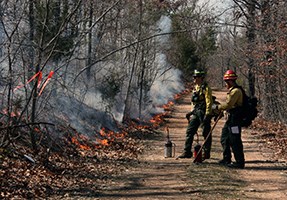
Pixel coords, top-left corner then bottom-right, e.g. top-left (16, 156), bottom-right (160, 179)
top-left (47, 16), bottom-right (184, 135)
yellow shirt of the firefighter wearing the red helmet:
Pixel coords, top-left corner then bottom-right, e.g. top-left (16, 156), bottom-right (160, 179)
top-left (218, 87), bottom-right (243, 111)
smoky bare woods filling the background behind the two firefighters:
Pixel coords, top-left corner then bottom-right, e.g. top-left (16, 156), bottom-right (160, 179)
top-left (0, 0), bottom-right (287, 149)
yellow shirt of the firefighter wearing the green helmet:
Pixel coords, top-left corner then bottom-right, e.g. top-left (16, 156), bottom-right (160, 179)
top-left (193, 83), bottom-right (213, 115)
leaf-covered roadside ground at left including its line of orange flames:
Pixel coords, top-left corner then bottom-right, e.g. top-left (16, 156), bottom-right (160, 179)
top-left (0, 87), bottom-right (194, 199)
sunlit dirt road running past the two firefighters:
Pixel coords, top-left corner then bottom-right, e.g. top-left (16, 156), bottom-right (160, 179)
top-left (95, 91), bottom-right (287, 200)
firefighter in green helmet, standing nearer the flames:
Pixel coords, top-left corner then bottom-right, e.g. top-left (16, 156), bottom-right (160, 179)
top-left (177, 69), bottom-right (213, 160)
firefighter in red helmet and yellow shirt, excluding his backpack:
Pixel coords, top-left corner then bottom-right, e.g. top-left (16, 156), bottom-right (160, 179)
top-left (215, 70), bottom-right (245, 169)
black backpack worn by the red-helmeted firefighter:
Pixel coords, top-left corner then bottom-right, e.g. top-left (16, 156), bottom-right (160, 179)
top-left (236, 86), bottom-right (258, 127)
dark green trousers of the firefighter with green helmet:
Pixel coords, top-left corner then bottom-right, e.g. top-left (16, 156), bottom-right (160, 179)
top-left (184, 110), bottom-right (212, 155)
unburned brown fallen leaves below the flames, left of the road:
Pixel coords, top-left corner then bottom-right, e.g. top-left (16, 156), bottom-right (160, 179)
top-left (0, 124), bottom-right (152, 199)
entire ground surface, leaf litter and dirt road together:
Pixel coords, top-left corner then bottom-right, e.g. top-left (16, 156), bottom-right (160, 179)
top-left (0, 90), bottom-right (287, 200)
